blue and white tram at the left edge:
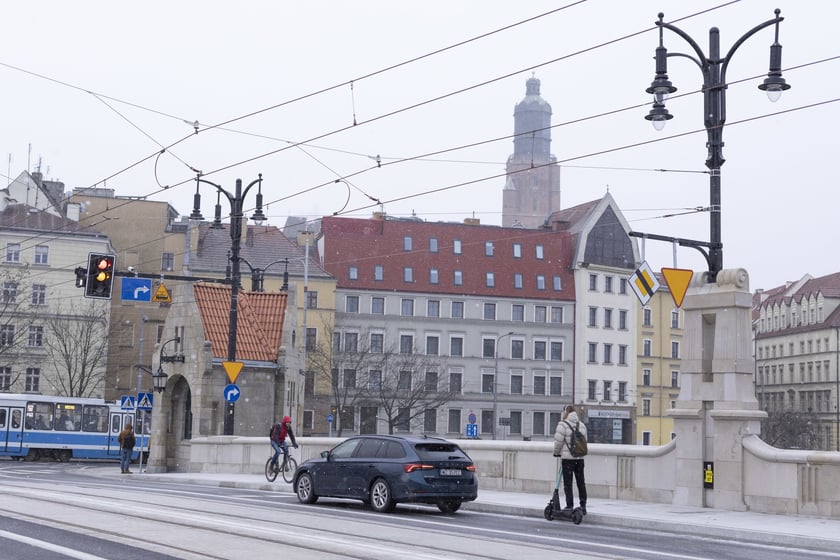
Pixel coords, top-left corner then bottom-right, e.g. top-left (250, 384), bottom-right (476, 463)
top-left (0, 393), bottom-right (151, 461)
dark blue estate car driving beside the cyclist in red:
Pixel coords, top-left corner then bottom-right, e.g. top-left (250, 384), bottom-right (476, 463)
top-left (293, 435), bottom-right (478, 513)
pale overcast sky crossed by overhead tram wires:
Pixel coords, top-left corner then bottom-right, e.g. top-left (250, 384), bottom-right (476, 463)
top-left (0, 0), bottom-right (840, 290)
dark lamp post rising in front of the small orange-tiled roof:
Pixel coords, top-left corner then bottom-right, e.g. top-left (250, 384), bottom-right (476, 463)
top-left (190, 173), bottom-right (266, 436)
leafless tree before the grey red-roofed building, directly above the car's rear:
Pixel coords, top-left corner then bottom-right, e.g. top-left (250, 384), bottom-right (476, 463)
top-left (365, 348), bottom-right (456, 434)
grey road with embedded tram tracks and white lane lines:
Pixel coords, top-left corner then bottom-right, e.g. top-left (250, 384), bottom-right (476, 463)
top-left (0, 461), bottom-right (837, 560)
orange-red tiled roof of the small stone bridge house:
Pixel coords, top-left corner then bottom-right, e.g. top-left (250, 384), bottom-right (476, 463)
top-left (193, 282), bottom-right (286, 362)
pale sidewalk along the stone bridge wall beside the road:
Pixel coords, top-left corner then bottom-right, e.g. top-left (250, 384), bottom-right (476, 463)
top-left (95, 465), bottom-right (840, 552)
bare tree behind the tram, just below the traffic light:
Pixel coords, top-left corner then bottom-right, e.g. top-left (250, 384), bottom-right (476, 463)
top-left (44, 300), bottom-right (108, 397)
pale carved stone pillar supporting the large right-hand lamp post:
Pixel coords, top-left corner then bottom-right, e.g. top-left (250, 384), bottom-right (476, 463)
top-left (668, 269), bottom-right (766, 511)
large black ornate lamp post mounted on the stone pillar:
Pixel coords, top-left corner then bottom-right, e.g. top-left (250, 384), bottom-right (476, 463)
top-left (645, 9), bottom-right (790, 282)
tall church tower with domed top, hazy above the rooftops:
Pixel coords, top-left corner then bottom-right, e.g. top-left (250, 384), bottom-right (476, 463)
top-left (502, 77), bottom-right (560, 228)
